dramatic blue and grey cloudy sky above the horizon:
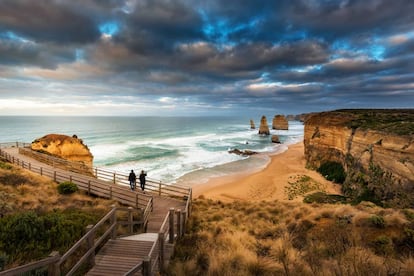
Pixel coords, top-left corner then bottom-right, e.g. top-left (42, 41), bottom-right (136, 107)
top-left (0, 0), bottom-right (414, 116)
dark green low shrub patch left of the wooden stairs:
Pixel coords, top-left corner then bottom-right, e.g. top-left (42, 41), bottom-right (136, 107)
top-left (0, 210), bottom-right (100, 263)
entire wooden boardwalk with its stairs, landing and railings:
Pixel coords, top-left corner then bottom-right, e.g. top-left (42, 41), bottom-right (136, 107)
top-left (0, 142), bottom-right (192, 275)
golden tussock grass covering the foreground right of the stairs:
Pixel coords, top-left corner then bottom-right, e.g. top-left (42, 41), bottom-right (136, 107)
top-left (166, 197), bottom-right (414, 275)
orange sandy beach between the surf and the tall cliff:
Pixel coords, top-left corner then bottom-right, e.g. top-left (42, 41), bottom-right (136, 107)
top-left (193, 142), bottom-right (340, 201)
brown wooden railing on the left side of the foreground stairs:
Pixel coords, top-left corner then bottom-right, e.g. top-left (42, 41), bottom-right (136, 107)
top-left (0, 206), bottom-right (148, 276)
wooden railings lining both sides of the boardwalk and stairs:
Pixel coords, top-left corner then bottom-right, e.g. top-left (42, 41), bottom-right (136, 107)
top-left (0, 142), bottom-right (192, 275)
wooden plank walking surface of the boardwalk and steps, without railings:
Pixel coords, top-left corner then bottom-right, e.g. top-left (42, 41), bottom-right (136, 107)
top-left (0, 147), bottom-right (191, 275)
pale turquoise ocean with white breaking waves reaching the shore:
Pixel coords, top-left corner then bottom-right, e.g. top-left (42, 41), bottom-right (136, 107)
top-left (0, 116), bottom-right (303, 185)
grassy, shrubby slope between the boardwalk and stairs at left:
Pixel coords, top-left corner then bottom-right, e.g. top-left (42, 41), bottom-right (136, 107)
top-left (0, 161), bottom-right (114, 269)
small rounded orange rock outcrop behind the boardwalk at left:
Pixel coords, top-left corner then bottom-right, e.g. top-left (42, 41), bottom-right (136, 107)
top-left (31, 134), bottom-right (93, 168)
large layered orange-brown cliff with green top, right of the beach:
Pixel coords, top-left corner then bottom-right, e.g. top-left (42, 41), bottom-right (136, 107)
top-left (304, 110), bottom-right (414, 207)
